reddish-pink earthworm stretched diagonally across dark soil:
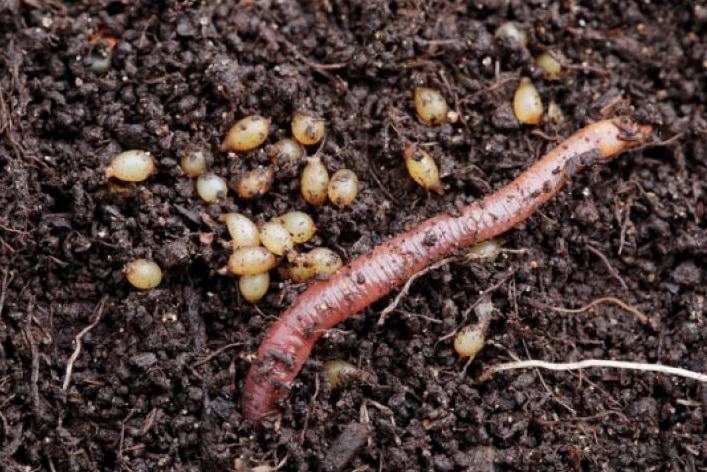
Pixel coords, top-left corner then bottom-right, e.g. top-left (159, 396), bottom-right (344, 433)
top-left (243, 117), bottom-right (652, 423)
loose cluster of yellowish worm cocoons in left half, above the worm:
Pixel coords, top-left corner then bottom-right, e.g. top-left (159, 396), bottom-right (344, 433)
top-left (105, 112), bottom-right (359, 302)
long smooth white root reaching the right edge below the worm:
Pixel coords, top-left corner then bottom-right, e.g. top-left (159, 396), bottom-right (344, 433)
top-left (479, 359), bottom-right (707, 382)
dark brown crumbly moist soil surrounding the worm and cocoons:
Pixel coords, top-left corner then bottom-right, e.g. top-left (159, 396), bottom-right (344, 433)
top-left (0, 0), bottom-right (707, 472)
